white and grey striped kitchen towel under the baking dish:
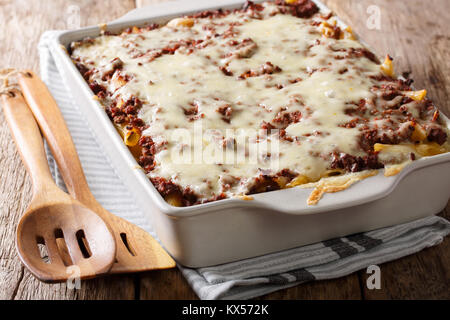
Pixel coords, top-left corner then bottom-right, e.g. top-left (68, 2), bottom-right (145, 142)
top-left (39, 31), bottom-right (450, 299)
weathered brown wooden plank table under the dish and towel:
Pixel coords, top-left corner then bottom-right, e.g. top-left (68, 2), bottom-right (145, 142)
top-left (0, 0), bottom-right (450, 299)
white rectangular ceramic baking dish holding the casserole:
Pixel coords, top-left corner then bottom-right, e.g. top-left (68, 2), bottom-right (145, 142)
top-left (51, 0), bottom-right (450, 267)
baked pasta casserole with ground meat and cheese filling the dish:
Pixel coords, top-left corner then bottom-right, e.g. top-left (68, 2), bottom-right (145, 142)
top-left (69, 0), bottom-right (450, 206)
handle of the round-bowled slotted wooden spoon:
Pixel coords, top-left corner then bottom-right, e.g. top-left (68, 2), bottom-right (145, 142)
top-left (1, 90), bottom-right (54, 194)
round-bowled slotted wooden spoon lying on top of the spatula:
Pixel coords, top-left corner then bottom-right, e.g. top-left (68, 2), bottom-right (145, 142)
top-left (2, 91), bottom-right (116, 282)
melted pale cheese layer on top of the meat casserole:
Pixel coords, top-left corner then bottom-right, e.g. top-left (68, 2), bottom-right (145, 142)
top-left (72, 3), bottom-right (446, 202)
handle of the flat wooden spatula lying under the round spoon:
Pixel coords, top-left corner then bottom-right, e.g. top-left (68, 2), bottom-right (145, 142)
top-left (19, 71), bottom-right (99, 208)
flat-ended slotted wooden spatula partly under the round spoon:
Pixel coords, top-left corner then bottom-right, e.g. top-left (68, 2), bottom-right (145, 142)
top-left (19, 71), bottom-right (175, 273)
